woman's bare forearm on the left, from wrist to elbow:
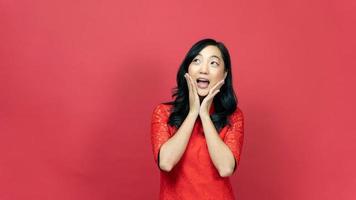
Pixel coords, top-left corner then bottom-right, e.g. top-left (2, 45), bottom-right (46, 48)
top-left (159, 113), bottom-right (198, 171)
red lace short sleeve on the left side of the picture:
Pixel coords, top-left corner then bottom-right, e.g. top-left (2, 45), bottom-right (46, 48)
top-left (151, 104), bottom-right (170, 168)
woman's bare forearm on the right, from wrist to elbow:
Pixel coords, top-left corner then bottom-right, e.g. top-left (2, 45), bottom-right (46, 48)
top-left (201, 115), bottom-right (235, 177)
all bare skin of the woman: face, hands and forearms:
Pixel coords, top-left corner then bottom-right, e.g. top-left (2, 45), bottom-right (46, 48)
top-left (159, 46), bottom-right (235, 177)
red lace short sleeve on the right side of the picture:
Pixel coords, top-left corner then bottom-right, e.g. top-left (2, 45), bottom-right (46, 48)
top-left (224, 108), bottom-right (244, 172)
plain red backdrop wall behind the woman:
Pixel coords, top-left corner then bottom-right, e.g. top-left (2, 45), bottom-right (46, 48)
top-left (0, 0), bottom-right (356, 200)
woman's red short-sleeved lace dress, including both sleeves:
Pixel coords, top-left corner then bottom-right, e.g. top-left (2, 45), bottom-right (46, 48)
top-left (151, 104), bottom-right (244, 200)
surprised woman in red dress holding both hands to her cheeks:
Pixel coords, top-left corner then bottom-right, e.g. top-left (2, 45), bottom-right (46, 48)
top-left (151, 39), bottom-right (244, 200)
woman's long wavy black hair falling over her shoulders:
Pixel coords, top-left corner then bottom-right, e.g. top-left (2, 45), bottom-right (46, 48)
top-left (163, 38), bottom-right (238, 133)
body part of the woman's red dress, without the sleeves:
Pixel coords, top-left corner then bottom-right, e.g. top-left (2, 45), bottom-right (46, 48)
top-left (160, 105), bottom-right (235, 200)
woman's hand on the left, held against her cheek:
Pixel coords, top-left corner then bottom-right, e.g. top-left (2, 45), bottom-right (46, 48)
top-left (184, 73), bottom-right (200, 115)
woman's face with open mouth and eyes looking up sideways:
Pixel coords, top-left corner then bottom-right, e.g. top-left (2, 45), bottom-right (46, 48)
top-left (188, 45), bottom-right (227, 97)
